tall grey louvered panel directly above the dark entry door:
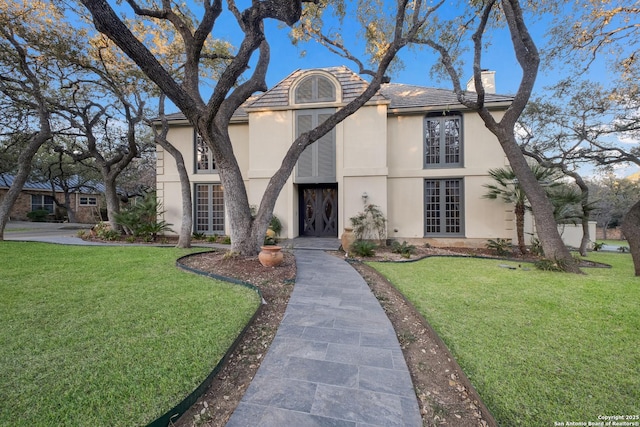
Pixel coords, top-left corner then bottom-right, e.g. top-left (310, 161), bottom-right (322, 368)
top-left (295, 109), bottom-right (336, 184)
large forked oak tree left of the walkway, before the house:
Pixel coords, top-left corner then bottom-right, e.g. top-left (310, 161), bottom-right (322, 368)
top-left (77, 0), bottom-right (442, 254)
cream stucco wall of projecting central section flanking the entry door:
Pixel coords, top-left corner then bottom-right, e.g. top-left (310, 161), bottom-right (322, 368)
top-left (248, 105), bottom-right (388, 237)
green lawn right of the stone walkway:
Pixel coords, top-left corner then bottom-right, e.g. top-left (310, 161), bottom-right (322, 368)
top-left (371, 253), bottom-right (640, 426)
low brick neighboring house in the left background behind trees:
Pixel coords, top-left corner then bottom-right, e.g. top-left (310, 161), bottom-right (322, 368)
top-left (0, 174), bottom-right (103, 224)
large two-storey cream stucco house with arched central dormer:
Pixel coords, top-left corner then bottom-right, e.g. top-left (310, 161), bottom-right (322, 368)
top-left (157, 67), bottom-right (515, 246)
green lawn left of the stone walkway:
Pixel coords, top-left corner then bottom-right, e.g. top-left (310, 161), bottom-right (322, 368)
top-left (0, 242), bottom-right (260, 426)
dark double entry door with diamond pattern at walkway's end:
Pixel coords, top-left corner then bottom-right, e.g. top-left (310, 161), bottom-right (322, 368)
top-left (300, 184), bottom-right (338, 237)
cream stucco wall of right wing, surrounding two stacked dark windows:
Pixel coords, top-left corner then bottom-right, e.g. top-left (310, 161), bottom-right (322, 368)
top-left (387, 113), bottom-right (513, 246)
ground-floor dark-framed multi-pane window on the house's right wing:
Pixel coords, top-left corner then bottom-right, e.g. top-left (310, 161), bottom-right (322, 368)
top-left (424, 179), bottom-right (464, 236)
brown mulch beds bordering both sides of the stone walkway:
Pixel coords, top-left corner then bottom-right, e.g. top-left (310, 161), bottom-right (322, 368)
top-left (175, 248), bottom-right (493, 427)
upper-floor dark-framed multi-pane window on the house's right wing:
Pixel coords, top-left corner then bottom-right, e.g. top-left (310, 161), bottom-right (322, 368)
top-left (424, 116), bottom-right (462, 168)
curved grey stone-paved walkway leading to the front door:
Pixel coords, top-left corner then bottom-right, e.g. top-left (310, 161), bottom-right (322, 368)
top-left (227, 251), bottom-right (422, 427)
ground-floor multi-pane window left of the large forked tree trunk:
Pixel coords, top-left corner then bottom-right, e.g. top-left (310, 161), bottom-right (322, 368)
top-left (194, 184), bottom-right (224, 235)
